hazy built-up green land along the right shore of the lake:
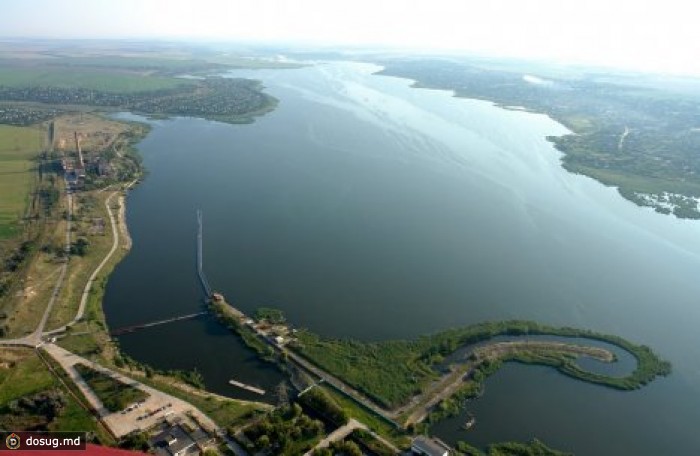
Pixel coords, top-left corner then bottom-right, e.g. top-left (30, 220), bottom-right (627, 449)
top-left (379, 59), bottom-right (700, 219)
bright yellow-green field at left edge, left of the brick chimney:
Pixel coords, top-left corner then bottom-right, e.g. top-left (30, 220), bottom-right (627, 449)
top-left (0, 125), bottom-right (42, 240)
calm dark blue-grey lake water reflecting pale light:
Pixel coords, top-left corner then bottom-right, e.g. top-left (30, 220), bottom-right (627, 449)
top-left (105, 63), bottom-right (700, 456)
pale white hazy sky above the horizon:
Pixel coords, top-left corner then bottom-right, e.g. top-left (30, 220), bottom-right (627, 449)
top-left (0, 0), bottom-right (700, 76)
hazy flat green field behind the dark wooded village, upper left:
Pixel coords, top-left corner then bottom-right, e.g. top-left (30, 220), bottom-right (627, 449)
top-left (0, 66), bottom-right (187, 93)
